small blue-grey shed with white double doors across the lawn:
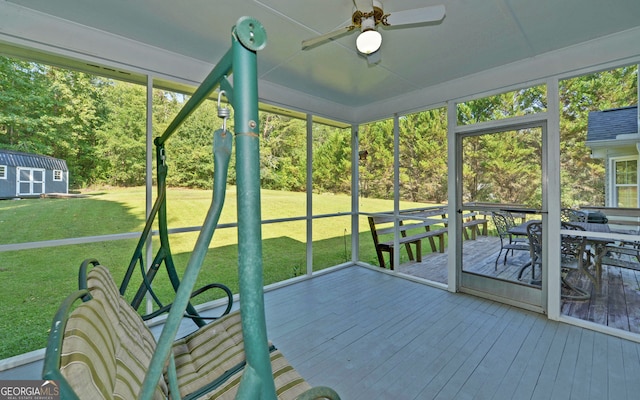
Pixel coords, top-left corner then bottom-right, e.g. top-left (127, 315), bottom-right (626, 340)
top-left (0, 149), bottom-right (69, 199)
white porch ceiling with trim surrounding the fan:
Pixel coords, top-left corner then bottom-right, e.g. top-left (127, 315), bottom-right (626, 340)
top-left (0, 0), bottom-right (640, 123)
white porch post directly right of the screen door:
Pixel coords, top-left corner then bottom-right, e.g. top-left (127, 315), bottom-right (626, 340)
top-left (542, 79), bottom-right (560, 320)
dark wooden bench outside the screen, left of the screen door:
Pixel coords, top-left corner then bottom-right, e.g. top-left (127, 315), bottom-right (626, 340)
top-left (368, 214), bottom-right (447, 270)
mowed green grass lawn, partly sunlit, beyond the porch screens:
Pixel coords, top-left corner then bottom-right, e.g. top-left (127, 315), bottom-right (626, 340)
top-left (0, 187), bottom-right (432, 359)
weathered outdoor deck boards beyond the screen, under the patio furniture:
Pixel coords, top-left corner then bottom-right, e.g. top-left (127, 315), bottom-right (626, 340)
top-left (398, 236), bottom-right (640, 333)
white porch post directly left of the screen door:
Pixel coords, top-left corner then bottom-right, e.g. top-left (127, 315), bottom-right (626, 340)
top-left (447, 101), bottom-right (462, 292)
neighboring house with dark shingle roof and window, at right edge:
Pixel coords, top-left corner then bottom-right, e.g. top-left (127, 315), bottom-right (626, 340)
top-left (586, 105), bottom-right (640, 208)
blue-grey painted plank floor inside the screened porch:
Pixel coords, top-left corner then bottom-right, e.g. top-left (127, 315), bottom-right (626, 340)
top-left (0, 267), bottom-right (640, 400)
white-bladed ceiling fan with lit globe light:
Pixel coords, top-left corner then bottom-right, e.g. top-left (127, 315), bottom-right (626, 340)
top-left (302, 0), bottom-right (445, 63)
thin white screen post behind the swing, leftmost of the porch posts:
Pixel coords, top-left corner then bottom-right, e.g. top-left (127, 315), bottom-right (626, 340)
top-left (145, 75), bottom-right (153, 314)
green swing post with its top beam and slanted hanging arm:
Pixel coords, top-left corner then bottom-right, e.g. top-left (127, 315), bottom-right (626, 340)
top-left (140, 17), bottom-right (276, 399)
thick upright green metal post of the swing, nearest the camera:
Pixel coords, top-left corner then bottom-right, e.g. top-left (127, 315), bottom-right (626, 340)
top-left (231, 18), bottom-right (276, 400)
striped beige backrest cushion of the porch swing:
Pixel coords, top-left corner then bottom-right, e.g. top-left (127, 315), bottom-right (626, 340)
top-left (61, 266), bottom-right (168, 399)
